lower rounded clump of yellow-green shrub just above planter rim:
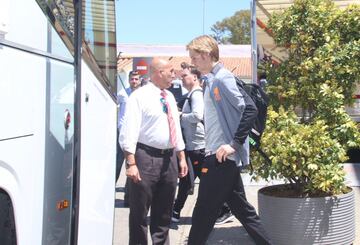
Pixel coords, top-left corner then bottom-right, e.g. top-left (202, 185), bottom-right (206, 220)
top-left (252, 107), bottom-right (346, 196)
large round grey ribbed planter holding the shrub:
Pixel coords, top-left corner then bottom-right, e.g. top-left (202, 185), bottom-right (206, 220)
top-left (258, 187), bottom-right (355, 245)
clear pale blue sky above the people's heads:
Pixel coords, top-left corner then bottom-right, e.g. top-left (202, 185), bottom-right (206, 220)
top-left (115, 0), bottom-right (250, 45)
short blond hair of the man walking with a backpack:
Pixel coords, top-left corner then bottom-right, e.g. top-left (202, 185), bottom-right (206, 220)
top-left (186, 35), bottom-right (219, 62)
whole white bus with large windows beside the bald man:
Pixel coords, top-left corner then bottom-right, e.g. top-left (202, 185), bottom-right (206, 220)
top-left (0, 0), bottom-right (117, 245)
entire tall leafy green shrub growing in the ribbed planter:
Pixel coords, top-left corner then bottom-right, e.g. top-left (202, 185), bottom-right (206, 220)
top-left (252, 0), bottom-right (360, 196)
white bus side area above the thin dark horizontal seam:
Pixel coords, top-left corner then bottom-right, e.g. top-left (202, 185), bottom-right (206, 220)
top-left (0, 46), bottom-right (46, 144)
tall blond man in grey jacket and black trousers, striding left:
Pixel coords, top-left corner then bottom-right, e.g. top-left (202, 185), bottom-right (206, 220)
top-left (186, 35), bottom-right (271, 245)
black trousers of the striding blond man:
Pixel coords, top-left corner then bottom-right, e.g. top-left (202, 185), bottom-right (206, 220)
top-left (188, 155), bottom-right (271, 245)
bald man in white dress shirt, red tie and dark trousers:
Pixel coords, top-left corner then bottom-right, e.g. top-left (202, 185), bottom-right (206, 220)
top-left (119, 58), bottom-right (188, 244)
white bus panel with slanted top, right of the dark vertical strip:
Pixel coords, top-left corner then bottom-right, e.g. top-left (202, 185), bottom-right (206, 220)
top-left (78, 59), bottom-right (117, 245)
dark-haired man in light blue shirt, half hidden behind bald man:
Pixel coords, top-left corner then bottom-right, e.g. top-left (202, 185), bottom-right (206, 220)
top-left (115, 71), bottom-right (141, 207)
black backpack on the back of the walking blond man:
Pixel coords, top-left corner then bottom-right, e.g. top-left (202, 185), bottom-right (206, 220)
top-left (234, 76), bottom-right (269, 148)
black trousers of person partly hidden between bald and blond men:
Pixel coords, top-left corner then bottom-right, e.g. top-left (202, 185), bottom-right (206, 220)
top-left (174, 149), bottom-right (205, 213)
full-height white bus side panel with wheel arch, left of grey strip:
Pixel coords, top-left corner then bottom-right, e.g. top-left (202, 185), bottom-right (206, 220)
top-left (0, 46), bottom-right (46, 245)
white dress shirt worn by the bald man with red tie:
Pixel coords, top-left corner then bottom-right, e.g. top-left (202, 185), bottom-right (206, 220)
top-left (119, 82), bottom-right (185, 154)
